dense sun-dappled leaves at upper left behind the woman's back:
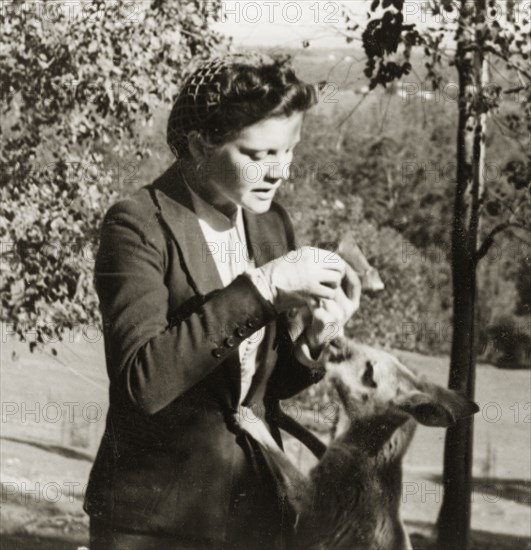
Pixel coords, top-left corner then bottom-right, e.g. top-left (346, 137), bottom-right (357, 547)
top-left (0, 0), bottom-right (225, 344)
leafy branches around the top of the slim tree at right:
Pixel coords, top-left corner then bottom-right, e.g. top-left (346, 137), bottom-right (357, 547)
top-left (352, 0), bottom-right (531, 252)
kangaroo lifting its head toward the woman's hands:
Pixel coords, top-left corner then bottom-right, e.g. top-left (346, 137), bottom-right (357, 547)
top-left (262, 339), bottom-right (479, 550)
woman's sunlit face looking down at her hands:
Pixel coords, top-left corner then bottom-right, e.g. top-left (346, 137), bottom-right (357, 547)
top-left (196, 113), bottom-right (303, 215)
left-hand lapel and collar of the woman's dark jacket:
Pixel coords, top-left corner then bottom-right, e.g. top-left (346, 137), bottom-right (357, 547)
top-left (153, 163), bottom-right (223, 295)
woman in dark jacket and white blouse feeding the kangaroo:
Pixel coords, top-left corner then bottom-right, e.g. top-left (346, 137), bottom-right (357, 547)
top-left (85, 55), bottom-right (359, 550)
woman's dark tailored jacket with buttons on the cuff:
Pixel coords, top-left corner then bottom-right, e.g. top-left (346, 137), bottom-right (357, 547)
top-left (84, 165), bottom-right (323, 548)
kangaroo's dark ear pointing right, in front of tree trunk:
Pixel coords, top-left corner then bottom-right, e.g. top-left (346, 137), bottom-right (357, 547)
top-left (396, 384), bottom-right (479, 427)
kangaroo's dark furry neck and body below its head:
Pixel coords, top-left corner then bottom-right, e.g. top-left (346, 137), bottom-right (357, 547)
top-left (297, 419), bottom-right (416, 550)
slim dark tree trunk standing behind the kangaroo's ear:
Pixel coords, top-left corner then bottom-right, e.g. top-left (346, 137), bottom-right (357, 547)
top-left (437, 0), bottom-right (488, 550)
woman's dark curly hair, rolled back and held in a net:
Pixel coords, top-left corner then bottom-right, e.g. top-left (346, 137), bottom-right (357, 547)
top-left (167, 54), bottom-right (318, 158)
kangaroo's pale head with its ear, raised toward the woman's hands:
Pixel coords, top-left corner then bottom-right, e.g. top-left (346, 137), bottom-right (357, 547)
top-left (326, 339), bottom-right (479, 427)
